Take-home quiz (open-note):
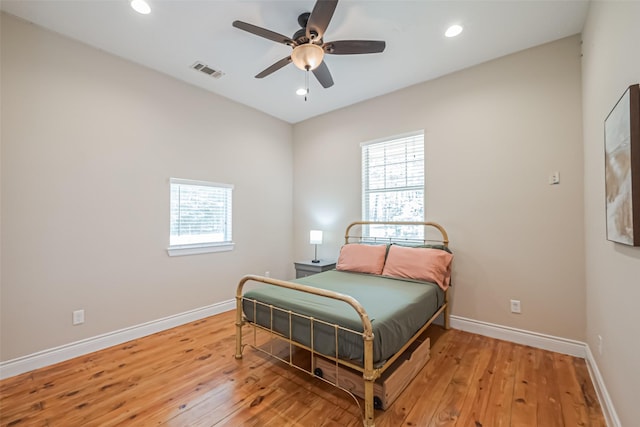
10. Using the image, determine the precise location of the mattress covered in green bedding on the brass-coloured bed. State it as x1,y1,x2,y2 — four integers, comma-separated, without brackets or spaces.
243,270,444,365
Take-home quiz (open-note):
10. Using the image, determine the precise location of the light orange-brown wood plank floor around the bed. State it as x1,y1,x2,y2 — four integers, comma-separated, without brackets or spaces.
0,313,606,427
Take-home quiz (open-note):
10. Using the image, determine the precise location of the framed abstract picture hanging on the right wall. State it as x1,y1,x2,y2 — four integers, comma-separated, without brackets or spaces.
604,84,640,246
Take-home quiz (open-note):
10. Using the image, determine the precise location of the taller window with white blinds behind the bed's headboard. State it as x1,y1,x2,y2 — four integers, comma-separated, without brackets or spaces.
362,131,424,238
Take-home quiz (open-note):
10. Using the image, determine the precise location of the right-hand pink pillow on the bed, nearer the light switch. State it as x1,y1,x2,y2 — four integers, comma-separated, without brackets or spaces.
382,245,453,290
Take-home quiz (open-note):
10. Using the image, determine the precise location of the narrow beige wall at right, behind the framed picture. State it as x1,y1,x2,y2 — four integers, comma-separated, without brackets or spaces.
582,1,640,426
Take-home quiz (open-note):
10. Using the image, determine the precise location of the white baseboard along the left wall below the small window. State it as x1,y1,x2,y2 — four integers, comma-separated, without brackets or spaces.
0,300,235,379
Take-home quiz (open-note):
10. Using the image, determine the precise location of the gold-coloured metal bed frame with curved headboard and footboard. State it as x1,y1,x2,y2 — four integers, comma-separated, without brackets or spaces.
235,221,450,427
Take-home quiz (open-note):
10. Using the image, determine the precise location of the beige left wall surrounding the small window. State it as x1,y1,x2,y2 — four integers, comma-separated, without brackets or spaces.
0,14,292,360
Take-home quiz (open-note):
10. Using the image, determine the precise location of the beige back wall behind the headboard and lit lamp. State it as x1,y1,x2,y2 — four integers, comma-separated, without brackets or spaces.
293,36,585,340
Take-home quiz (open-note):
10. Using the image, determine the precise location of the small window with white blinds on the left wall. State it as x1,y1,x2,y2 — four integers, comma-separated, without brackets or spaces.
168,178,234,256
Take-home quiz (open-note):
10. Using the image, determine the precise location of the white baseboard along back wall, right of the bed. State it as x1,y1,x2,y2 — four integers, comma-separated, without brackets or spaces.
451,316,587,359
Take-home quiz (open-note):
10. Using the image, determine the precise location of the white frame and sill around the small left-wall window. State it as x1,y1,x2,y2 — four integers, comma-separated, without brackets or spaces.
167,178,235,256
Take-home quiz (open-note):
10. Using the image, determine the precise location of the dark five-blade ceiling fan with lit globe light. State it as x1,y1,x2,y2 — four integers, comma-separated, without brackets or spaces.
233,0,385,88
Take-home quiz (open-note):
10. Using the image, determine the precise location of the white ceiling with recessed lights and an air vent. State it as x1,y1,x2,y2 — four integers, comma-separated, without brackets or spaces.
1,0,589,123
